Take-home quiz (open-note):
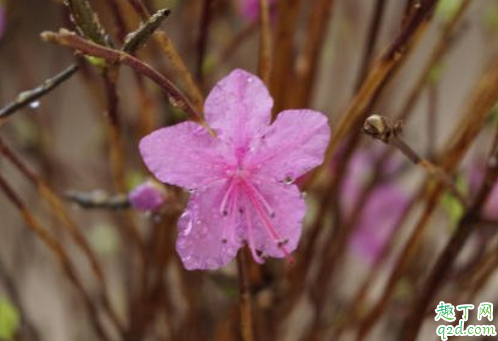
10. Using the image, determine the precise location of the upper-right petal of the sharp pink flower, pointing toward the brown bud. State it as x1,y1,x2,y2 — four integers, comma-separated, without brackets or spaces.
249,109,330,180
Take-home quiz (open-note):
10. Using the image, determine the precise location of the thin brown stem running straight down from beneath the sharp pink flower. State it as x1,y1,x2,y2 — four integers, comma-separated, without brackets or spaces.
237,250,255,341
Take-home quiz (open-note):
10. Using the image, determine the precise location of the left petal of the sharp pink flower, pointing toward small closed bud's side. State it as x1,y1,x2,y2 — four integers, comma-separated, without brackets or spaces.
140,122,225,189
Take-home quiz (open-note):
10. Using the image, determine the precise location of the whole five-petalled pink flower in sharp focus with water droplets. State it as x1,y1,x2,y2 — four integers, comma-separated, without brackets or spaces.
140,70,330,270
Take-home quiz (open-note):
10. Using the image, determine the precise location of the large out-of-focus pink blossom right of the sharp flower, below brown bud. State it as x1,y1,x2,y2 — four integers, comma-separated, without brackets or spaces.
341,151,409,264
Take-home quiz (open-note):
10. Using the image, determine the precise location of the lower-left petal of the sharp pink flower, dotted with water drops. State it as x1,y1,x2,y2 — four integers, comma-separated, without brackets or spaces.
176,183,241,270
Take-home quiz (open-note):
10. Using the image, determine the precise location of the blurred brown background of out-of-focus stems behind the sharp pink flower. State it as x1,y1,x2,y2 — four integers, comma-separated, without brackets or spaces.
0,0,498,341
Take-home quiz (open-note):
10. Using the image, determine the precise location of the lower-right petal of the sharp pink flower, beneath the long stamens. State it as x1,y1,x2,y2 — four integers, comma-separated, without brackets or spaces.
241,181,306,258
